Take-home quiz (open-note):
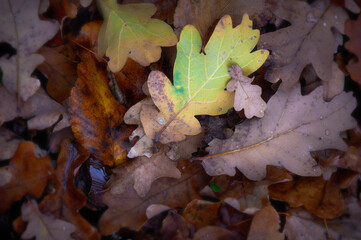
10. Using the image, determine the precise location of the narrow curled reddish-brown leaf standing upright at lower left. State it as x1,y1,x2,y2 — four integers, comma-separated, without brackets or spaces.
39,140,99,239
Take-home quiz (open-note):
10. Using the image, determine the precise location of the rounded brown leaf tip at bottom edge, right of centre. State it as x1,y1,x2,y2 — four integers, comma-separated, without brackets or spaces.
247,206,285,240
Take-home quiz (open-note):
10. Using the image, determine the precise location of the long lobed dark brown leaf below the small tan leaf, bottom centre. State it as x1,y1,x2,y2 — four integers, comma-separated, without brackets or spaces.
98,161,209,235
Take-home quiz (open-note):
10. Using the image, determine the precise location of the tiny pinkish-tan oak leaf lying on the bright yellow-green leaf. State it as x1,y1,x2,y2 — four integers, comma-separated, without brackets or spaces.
227,65,267,118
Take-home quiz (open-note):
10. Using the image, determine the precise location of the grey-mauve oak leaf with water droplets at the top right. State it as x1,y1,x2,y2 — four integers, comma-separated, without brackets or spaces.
259,0,348,95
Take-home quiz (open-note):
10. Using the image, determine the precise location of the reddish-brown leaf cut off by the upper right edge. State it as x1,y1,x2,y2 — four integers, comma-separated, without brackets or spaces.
345,13,361,85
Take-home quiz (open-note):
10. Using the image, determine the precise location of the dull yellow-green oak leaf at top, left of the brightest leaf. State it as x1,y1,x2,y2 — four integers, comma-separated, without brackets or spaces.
97,0,177,72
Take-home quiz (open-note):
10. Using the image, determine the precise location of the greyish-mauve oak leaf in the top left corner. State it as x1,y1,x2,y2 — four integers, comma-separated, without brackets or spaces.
0,0,59,101
